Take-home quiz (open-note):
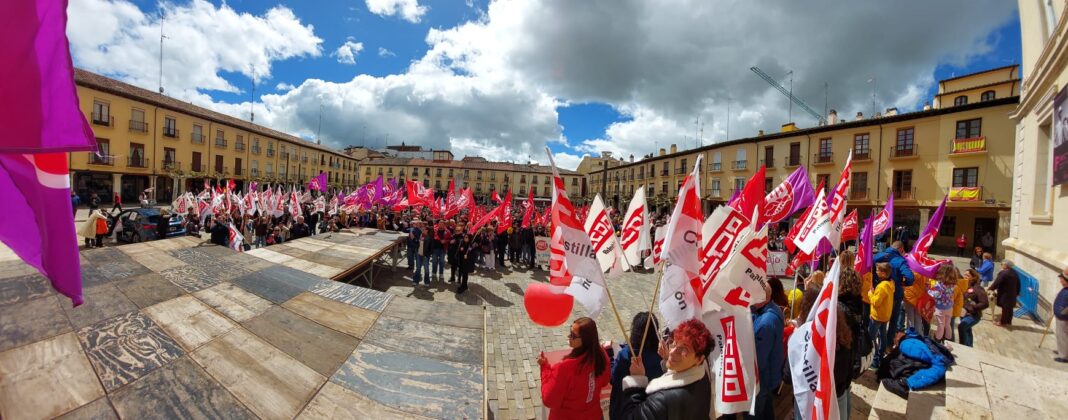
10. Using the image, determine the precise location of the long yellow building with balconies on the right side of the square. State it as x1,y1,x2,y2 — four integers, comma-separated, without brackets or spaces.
587,66,1020,254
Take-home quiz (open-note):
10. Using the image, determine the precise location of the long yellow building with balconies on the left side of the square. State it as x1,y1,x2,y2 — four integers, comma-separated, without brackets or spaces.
69,69,357,202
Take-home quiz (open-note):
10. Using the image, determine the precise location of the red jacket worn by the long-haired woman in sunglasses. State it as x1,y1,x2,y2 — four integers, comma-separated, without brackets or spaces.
541,349,612,420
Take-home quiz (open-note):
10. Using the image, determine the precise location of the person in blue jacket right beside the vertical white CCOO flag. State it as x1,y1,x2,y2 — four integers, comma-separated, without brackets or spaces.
745,283,786,419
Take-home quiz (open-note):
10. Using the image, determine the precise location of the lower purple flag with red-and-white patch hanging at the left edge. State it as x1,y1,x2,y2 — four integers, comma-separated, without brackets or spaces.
0,153,82,307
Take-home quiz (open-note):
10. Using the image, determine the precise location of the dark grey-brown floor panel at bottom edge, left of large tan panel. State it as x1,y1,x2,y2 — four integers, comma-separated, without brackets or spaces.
111,357,256,419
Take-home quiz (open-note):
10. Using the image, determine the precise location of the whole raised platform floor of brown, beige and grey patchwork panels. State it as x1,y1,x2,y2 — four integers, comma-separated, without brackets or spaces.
0,230,485,419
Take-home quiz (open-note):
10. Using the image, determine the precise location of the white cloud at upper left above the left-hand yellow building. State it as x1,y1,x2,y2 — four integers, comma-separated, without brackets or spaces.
67,0,323,98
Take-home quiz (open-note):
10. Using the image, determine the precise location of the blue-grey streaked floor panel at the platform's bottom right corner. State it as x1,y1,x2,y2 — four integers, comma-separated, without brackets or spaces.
330,342,483,419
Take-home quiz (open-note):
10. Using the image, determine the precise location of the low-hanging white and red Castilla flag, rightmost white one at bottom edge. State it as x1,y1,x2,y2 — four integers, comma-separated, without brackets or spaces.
786,260,842,420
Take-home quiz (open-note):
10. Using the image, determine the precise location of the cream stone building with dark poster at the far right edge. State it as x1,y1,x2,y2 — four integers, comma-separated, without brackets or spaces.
1003,1,1068,314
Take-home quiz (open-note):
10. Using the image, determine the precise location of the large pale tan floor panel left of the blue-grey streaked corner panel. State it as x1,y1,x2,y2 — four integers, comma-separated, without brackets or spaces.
192,328,326,419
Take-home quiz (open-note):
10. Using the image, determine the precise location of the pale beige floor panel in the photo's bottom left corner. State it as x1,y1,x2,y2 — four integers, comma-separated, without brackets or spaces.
0,331,104,419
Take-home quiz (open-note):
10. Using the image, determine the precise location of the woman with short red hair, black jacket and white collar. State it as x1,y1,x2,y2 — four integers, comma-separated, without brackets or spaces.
619,320,713,419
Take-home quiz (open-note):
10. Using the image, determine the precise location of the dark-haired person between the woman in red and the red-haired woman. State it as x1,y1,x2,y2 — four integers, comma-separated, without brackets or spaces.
608,312,664,420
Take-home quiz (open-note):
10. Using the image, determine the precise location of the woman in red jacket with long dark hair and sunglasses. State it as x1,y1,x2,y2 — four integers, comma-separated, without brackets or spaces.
537,317,609,420
